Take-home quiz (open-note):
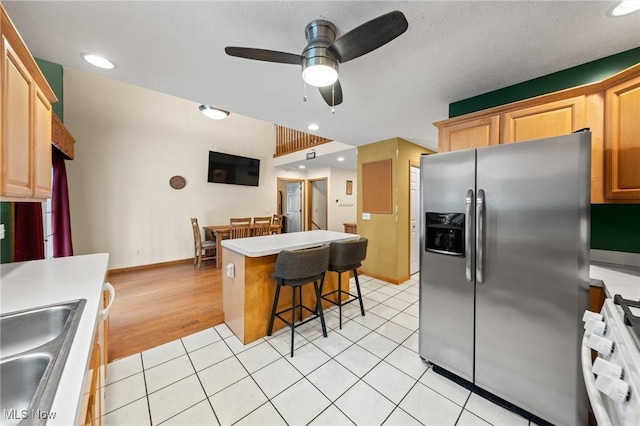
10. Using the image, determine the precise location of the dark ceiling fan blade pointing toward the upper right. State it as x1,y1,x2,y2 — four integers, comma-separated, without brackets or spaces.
328,10,409,62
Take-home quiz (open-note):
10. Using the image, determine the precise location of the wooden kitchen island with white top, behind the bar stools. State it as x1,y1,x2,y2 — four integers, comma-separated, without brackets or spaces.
222,230,359,345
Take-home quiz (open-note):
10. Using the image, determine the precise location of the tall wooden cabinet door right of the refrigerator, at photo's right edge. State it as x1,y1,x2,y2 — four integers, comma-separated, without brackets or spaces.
605,76,640,202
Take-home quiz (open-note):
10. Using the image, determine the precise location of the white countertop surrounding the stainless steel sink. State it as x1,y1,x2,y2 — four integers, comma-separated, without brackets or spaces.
0,253,109,425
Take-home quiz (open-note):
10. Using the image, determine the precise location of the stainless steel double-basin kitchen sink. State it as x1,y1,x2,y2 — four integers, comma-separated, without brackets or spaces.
0,299,86,426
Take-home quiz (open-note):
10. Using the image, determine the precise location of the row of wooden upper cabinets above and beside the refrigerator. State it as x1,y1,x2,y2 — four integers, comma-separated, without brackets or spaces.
434,64,640,203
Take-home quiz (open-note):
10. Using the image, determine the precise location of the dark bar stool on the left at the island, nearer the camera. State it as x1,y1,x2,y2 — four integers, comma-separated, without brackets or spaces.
267,245,330,357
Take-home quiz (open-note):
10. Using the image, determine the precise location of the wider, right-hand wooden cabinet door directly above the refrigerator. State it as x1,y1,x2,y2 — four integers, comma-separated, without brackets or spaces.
501,96,586,143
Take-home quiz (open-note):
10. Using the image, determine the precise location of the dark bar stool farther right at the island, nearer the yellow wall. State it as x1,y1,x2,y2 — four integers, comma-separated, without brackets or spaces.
321,238,369,329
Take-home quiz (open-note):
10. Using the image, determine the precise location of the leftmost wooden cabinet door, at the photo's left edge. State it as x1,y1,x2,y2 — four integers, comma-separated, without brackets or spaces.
0,39,33,197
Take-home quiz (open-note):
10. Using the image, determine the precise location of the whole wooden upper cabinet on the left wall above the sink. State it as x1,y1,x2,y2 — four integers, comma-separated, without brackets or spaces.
0,4,57,200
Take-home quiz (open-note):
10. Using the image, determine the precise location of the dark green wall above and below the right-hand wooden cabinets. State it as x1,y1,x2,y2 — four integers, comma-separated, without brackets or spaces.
449,47,640,253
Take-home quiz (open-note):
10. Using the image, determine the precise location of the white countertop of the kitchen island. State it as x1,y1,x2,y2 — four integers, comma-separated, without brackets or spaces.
222,230,360,257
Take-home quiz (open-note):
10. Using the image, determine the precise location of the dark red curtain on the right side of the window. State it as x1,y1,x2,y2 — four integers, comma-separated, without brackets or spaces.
51,146,73,257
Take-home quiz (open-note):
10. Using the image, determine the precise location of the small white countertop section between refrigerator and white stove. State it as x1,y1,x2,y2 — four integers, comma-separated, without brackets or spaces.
589,262,640,300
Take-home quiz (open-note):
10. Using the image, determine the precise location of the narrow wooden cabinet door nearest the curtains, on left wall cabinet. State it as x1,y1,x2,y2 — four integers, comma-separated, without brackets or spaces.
33,87,51,198
